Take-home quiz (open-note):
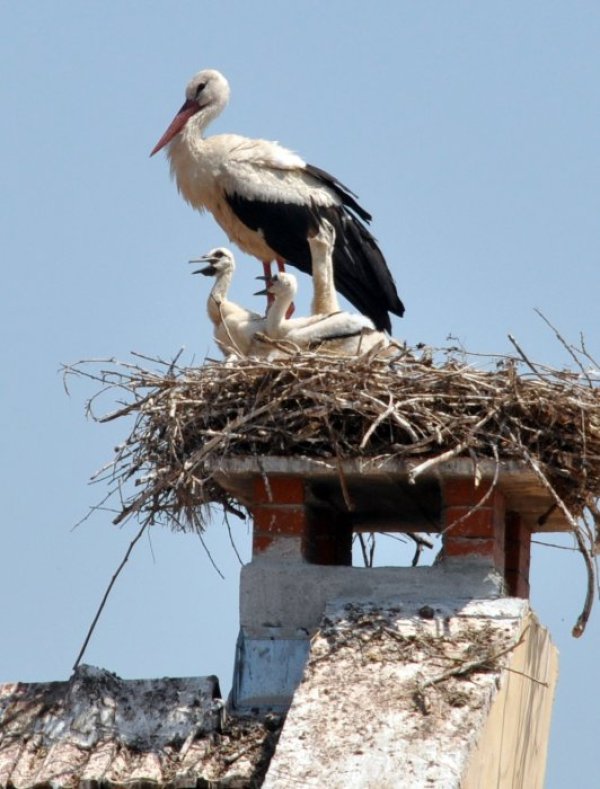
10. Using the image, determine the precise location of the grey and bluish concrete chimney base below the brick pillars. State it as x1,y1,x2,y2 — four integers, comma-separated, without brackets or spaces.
232,558,508,711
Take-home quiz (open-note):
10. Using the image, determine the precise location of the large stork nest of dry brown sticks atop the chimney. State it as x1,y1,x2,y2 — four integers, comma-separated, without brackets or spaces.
65,343,600,636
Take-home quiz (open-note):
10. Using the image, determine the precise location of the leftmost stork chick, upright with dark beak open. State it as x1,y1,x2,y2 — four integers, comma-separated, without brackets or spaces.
190,247,265,359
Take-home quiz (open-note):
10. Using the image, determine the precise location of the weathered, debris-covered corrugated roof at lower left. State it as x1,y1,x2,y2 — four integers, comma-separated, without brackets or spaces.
0,666,281,789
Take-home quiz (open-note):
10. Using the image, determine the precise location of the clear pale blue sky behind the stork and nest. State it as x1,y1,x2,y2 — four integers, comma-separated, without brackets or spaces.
0,0,600,789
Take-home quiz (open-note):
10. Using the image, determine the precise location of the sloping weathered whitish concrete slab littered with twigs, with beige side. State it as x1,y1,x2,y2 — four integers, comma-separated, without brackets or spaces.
264,600,556,789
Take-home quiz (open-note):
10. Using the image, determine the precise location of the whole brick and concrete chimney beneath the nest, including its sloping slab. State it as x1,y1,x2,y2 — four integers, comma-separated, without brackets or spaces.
219,457,569,787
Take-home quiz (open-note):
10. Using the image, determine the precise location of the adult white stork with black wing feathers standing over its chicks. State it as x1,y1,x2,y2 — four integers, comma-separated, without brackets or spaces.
150,63,404,331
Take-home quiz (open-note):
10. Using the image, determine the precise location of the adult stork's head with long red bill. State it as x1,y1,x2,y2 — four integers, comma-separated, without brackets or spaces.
150,69,229,156
